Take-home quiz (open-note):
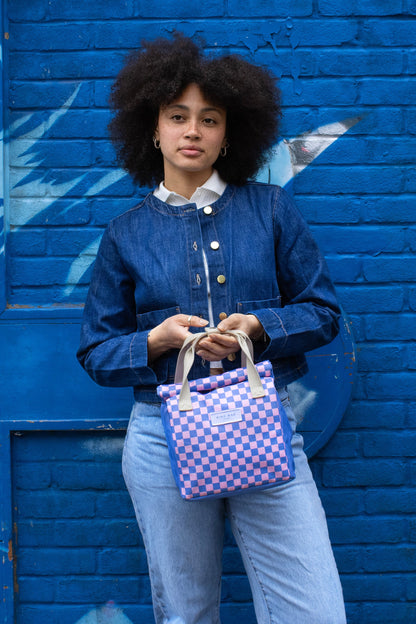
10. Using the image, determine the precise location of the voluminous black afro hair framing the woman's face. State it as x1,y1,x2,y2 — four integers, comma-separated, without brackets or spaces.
109,33,281,187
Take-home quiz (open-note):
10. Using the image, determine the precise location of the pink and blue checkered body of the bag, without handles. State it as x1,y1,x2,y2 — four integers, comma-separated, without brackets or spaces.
158,361,295,499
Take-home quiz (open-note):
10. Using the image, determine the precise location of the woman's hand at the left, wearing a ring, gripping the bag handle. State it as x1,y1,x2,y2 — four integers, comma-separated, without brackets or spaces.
147,314,208,364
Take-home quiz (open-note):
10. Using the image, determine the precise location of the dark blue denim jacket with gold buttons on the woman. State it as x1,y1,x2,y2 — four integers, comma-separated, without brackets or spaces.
77,183,340,401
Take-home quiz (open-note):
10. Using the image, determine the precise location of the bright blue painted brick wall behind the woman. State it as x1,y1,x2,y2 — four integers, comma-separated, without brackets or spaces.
0,0,416,624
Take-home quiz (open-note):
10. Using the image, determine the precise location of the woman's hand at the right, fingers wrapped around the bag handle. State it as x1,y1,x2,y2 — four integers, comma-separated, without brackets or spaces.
196,313,264,362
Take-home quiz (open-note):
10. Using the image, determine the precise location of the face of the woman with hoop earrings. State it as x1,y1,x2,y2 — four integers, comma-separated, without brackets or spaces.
155,84,227,190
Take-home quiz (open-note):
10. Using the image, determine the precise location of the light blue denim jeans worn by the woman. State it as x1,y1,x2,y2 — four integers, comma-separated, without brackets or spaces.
123,391,346,624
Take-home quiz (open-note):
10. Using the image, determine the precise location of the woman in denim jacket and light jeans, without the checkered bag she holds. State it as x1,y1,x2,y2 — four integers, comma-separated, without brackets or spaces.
78,35,345,624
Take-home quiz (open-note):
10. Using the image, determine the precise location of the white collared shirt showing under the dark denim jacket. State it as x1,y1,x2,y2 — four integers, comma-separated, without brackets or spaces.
153,169,227,368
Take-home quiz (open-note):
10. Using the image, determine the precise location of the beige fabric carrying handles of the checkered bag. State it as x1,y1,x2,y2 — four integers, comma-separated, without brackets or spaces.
175,327,266,412
